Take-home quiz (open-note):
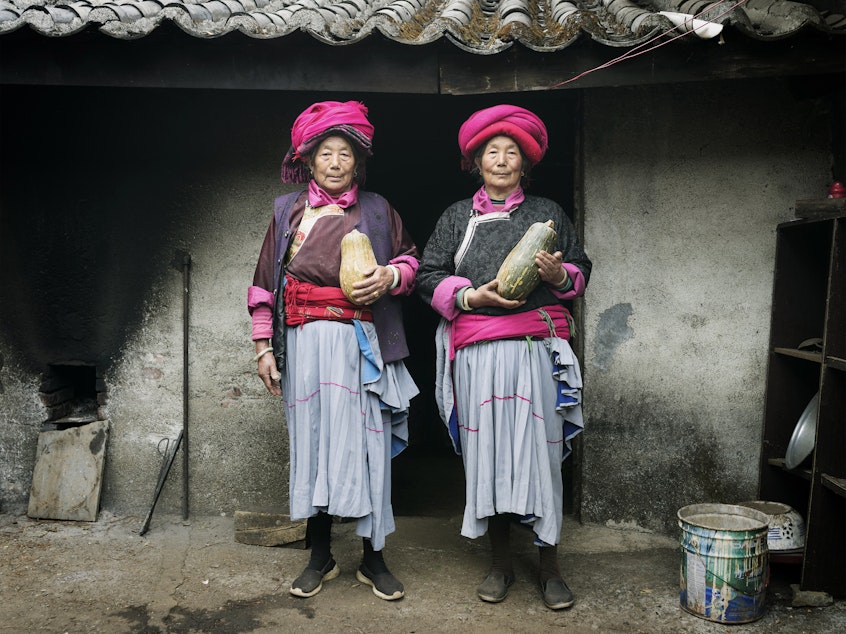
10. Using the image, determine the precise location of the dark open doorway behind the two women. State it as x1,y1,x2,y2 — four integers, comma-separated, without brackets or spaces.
362,92,576,516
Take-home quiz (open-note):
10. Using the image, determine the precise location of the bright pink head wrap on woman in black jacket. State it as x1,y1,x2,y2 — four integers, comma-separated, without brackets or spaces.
458,104,549,170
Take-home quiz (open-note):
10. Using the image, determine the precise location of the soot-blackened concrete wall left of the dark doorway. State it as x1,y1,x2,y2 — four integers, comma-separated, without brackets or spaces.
0,88,307,515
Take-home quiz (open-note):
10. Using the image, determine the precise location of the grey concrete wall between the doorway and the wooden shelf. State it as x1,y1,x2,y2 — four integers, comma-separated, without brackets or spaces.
582,82,831,531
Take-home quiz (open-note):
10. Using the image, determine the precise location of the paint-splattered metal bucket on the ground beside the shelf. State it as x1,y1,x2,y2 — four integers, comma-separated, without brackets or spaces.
678,504,770,623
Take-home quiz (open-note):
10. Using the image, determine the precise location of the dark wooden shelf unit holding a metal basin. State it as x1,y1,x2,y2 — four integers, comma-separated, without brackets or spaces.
759,215,846,598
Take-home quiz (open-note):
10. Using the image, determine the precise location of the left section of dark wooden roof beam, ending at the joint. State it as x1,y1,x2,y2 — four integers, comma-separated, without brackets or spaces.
0,23,438,94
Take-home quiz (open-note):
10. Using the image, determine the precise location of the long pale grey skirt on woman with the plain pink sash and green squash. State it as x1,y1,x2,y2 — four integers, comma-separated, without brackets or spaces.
452,337,584,545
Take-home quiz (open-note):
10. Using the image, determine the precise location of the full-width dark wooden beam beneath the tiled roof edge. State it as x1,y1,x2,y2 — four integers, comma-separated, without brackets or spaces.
0,23,846,95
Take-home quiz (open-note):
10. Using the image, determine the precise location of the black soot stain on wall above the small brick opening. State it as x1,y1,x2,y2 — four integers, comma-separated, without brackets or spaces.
0,87,260,370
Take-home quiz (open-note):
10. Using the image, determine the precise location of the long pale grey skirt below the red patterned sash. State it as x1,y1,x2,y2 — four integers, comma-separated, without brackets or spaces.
282,320,418,550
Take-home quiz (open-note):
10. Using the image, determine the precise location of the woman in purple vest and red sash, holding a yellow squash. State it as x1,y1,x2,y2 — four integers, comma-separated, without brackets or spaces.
248,101,419,600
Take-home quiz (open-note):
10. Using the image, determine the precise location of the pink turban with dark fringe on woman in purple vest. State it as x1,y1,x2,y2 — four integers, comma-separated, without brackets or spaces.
282,101,373,183
